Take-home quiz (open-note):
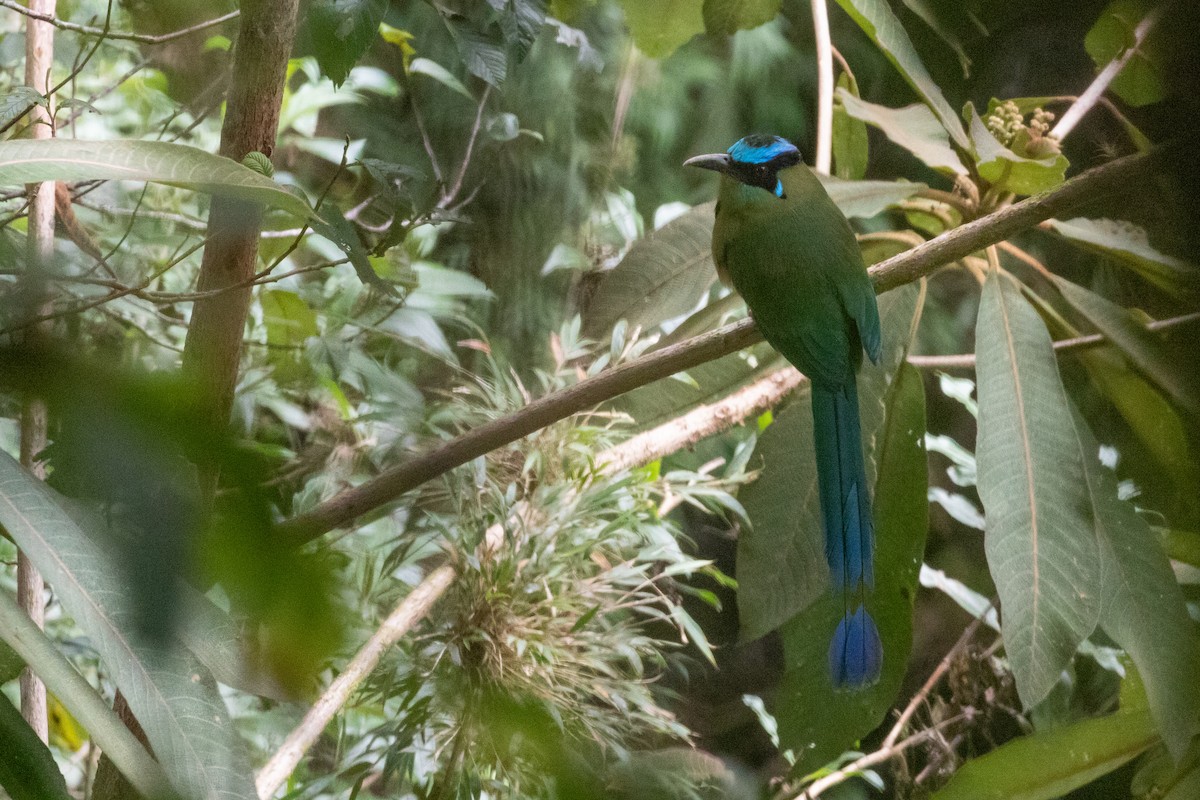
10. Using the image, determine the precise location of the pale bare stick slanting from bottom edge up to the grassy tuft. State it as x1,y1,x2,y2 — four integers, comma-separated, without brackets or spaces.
254,565,455,800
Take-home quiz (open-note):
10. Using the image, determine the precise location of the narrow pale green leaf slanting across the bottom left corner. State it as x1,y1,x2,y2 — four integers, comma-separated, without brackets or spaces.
0,591,167,798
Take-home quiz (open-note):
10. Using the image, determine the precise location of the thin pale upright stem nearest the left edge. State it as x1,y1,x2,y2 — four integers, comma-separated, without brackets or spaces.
17,0,58,741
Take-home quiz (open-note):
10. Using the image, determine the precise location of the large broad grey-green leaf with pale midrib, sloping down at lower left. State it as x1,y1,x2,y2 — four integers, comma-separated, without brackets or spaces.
0,453,256,800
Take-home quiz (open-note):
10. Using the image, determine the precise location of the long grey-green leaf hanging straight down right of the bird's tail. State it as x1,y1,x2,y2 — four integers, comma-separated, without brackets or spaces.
976,271,1100,708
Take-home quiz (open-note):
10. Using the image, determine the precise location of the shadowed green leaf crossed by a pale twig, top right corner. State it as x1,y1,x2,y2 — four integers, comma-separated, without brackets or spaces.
1084,0,1166,107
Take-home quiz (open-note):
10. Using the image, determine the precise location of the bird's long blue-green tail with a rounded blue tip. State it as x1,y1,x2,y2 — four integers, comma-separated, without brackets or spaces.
812,380,883,688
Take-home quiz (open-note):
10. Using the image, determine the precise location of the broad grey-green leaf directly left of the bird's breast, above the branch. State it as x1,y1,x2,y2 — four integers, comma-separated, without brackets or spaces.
583,203,716,339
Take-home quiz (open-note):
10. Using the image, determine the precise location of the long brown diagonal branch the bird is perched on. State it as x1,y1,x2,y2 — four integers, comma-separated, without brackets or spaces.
277,143,1183,545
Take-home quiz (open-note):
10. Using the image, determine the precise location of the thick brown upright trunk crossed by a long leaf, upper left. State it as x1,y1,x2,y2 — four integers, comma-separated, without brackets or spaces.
184,0,299,450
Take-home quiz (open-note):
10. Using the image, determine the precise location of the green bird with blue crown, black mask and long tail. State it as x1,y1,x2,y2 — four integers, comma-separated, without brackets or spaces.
684,134,883,688
